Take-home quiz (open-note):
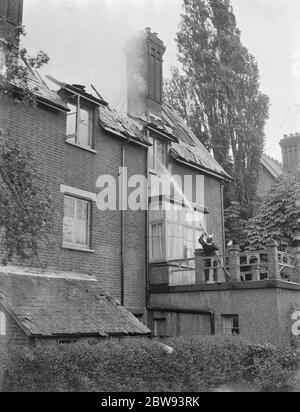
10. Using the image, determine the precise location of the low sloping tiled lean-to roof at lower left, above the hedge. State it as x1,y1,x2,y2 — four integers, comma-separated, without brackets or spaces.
0,272,150,337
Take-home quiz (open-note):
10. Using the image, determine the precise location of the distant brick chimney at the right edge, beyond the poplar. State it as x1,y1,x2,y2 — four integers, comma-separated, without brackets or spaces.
280,133,300,172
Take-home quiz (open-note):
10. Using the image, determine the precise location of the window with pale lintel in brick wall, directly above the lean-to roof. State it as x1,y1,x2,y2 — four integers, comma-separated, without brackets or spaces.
63,196,91,249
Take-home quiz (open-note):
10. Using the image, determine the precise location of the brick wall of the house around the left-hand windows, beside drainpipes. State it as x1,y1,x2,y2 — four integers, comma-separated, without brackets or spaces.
0,97,146,312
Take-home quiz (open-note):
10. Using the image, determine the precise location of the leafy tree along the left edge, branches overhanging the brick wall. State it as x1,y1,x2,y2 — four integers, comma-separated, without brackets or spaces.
0,28,52,264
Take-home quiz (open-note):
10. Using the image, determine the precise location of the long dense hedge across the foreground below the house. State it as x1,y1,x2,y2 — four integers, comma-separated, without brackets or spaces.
0,336,300,392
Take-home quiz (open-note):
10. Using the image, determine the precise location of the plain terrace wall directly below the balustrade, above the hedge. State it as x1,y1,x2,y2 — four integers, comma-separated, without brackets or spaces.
151,283,299,346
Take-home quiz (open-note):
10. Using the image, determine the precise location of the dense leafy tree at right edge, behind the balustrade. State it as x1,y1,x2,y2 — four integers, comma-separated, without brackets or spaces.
246,169,300,249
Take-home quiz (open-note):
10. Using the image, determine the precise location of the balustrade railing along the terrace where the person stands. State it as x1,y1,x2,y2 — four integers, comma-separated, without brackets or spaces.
168,242,300,286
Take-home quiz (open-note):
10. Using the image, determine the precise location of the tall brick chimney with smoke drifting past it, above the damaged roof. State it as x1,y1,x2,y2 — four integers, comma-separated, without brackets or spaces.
125,27,166,118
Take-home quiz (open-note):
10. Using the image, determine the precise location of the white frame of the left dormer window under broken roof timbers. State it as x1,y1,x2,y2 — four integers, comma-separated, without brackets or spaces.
66,95,94,151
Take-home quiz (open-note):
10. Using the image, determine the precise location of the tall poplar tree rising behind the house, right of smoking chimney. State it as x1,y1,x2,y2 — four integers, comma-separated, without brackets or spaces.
165,0,269,219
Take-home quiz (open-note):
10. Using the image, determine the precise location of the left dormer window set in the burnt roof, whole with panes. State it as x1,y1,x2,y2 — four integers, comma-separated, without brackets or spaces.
67,96,94,149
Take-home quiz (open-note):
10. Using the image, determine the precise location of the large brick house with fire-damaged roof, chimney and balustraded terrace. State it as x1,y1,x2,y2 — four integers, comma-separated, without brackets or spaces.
0,0,300,344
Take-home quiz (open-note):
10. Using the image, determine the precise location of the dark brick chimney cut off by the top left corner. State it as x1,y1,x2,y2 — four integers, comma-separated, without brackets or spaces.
0,0,23,43
